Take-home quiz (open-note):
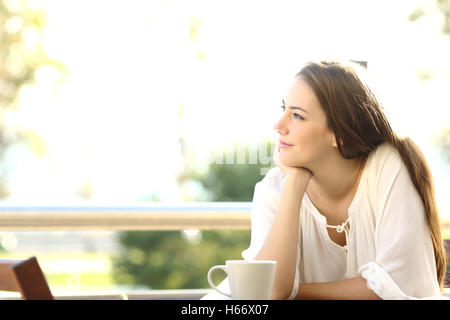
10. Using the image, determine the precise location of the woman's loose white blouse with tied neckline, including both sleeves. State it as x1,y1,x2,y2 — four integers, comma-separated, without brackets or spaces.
204,142,443,299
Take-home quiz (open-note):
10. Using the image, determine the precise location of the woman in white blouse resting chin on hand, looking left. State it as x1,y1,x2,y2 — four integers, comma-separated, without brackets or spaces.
204,62,446,299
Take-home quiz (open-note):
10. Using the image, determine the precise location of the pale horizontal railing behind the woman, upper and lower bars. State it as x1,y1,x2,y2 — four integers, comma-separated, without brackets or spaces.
0,202,450,299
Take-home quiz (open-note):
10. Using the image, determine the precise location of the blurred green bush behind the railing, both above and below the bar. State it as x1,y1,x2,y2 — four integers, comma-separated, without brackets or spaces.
113,142,272,289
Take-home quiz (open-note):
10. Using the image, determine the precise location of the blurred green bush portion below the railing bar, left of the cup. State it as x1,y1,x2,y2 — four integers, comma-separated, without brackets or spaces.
113,230,250,289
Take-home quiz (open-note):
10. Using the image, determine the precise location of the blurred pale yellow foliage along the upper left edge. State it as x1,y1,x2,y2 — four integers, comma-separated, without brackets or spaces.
0,0,68,198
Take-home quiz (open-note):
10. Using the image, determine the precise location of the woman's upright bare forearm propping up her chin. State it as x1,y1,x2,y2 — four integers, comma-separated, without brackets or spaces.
255,172,310,299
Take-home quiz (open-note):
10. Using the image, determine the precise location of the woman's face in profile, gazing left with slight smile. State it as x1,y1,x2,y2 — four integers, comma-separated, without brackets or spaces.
274,78,335,169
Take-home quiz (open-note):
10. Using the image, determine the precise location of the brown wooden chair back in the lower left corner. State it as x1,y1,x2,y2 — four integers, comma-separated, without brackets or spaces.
0,257,54,300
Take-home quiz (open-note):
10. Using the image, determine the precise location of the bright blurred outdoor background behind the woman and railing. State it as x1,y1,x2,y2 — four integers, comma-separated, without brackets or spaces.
0,0,450,291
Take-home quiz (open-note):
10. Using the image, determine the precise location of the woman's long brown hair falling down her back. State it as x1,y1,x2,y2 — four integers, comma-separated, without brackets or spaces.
296,61,447,289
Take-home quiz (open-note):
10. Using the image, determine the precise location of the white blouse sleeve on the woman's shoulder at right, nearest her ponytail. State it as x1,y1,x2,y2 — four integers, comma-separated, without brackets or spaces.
358,151,441,299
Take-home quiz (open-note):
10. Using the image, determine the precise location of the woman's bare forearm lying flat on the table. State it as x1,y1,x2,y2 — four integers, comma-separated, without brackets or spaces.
295,277,380,300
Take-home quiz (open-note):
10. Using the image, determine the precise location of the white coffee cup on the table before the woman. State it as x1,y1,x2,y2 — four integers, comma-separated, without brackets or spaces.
208,260,277,300
